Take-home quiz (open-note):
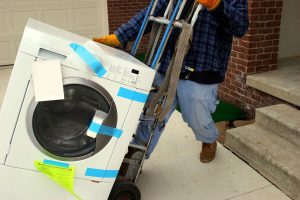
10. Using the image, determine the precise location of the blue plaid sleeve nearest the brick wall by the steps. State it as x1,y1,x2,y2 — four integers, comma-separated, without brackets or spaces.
211,0,249,37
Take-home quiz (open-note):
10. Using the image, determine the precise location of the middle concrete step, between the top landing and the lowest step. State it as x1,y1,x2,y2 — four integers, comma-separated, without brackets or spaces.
255,104,300,146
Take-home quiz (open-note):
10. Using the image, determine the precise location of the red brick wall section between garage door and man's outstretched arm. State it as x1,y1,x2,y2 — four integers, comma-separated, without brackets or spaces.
107,0,150,52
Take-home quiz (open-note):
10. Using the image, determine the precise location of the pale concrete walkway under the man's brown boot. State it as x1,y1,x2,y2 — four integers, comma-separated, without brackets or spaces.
0,68,289,200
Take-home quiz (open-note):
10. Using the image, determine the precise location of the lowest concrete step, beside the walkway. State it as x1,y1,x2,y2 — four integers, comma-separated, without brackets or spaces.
225,124,300,200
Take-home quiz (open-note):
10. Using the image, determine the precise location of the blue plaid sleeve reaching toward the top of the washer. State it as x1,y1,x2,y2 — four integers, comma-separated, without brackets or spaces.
114,0,168,47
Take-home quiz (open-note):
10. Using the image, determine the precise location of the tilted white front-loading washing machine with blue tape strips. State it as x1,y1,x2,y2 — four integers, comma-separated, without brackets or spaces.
0,19,155,200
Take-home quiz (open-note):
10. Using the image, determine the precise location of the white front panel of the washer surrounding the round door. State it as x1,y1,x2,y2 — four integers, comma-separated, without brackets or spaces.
5,67,134,181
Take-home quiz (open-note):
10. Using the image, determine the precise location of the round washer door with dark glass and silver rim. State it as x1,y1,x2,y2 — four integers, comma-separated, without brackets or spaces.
29,78,117,160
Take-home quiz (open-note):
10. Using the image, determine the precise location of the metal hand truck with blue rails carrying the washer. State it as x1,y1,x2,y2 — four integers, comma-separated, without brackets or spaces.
109,0,202,200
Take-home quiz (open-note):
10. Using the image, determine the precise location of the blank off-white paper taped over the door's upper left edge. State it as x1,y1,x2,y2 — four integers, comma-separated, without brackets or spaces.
32,60,64,102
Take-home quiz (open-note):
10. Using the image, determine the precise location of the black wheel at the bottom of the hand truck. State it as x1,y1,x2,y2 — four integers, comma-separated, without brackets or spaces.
108,182,141,200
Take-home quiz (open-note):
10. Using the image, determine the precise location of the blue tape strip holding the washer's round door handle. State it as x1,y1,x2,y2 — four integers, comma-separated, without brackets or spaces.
89,122,123,138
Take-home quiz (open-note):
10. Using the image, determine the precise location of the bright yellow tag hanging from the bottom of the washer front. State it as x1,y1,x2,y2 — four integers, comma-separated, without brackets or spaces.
34,161,81,199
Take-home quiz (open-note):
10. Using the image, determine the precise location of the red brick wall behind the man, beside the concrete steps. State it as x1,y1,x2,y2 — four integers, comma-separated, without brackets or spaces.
219,0,283,115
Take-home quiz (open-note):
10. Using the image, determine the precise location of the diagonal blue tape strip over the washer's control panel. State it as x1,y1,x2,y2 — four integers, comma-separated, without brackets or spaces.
70,43,107,77
